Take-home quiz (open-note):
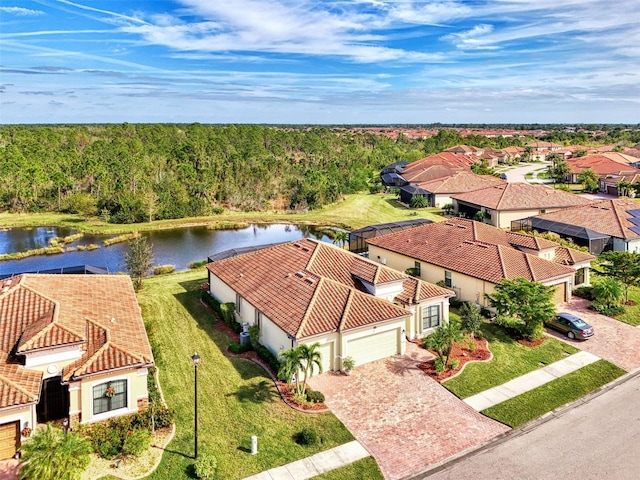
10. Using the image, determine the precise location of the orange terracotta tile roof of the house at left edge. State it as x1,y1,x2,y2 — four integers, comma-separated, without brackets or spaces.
0,274,153,406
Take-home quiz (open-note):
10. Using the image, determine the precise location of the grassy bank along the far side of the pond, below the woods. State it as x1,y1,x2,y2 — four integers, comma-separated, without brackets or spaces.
0,193,442,235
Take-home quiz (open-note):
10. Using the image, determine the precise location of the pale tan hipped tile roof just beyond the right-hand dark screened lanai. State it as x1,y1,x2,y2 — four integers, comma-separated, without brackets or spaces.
451,183,591,211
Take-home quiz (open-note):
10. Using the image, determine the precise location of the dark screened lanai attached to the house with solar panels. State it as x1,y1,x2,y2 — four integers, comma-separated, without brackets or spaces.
511,217,612,255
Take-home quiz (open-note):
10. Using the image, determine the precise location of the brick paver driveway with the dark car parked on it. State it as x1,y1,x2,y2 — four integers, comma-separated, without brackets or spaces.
547,298,640,372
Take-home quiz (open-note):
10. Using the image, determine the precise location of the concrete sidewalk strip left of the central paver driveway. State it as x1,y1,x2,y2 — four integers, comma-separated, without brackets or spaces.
245,440,370,480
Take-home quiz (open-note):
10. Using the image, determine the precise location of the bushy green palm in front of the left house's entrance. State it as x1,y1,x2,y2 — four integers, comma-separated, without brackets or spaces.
19,424,92,480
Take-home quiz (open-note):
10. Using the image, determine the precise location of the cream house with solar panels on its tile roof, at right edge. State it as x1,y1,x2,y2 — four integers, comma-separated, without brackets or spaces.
511,198,640,255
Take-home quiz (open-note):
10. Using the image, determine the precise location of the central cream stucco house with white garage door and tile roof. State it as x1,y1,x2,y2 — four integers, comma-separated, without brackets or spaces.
207,239,453,371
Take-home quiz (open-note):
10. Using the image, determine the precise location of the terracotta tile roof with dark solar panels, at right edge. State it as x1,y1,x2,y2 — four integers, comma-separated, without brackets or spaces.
537,198,640,240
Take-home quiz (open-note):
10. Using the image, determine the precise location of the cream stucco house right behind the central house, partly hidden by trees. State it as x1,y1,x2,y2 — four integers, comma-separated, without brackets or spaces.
368,218,595,306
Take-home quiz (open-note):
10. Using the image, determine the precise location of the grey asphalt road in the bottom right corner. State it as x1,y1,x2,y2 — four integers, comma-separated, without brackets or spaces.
414,375,640,480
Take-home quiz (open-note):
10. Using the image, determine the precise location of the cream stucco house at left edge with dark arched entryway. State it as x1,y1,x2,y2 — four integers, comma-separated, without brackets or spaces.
0,274,153,459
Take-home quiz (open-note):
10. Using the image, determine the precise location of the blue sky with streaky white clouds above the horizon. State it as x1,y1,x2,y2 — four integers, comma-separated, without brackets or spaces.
0,0,640,124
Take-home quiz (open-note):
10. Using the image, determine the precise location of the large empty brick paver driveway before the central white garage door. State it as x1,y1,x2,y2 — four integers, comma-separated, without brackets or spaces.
310,343,509,480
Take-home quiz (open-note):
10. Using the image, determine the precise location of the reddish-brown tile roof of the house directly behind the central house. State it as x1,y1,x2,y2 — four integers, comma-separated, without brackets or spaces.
368,218,584,283
